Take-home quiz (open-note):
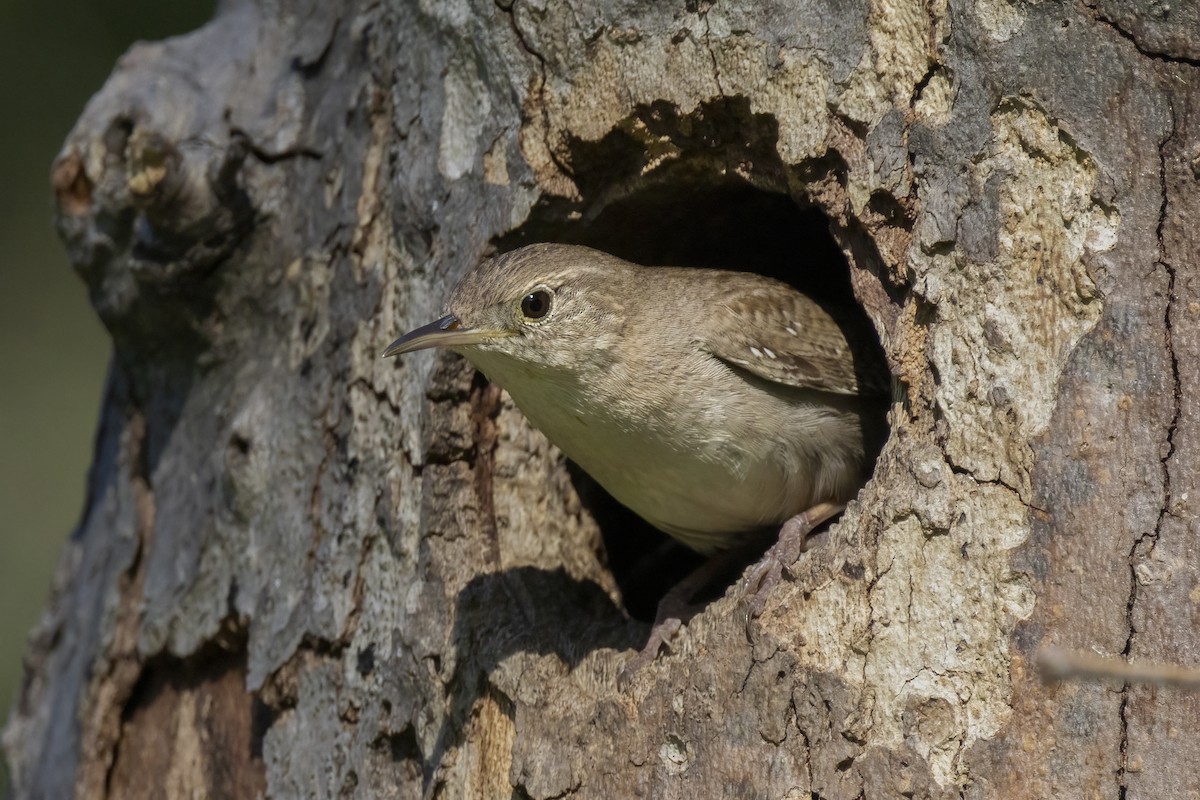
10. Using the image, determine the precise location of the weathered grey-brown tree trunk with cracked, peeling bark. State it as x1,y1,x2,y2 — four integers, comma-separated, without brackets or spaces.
4,0,1200,799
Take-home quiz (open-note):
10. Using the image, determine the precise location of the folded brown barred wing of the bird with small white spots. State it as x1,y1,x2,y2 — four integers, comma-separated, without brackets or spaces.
703,283,889,395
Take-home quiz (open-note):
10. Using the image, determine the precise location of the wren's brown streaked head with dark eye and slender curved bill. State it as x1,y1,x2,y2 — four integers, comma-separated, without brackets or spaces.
384,243,637,383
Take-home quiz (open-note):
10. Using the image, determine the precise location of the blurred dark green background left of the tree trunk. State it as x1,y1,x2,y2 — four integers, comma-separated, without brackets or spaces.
0,0,214,795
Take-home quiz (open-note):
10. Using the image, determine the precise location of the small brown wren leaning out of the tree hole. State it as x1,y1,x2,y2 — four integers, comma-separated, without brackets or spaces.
384,243,890,669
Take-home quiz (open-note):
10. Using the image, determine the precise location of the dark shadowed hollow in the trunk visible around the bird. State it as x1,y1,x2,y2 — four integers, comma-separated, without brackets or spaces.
496,167,886,620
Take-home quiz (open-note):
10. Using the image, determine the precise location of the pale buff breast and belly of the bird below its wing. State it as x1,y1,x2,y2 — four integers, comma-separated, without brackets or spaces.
494,362,860,553
